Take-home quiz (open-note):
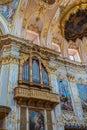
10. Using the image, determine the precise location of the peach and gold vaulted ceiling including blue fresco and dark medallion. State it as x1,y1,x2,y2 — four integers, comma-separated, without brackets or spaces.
0,0,87,46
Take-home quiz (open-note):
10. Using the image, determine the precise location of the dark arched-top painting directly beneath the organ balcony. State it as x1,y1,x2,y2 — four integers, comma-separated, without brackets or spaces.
29,111,45,130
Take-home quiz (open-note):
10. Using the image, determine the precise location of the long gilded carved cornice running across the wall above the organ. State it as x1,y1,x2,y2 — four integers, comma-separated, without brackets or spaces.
0,35,87,70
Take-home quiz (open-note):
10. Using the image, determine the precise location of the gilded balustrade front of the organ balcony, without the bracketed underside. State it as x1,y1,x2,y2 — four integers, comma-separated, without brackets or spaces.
14,87,59,106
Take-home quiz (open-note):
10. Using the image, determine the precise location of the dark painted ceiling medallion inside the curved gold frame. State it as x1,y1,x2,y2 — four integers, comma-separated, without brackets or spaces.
64,9,87,42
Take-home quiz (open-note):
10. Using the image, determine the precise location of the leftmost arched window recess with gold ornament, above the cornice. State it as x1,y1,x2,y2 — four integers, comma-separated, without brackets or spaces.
26,12,44,45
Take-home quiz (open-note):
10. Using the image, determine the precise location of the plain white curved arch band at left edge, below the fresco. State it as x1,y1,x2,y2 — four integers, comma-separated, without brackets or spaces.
0,14,10,34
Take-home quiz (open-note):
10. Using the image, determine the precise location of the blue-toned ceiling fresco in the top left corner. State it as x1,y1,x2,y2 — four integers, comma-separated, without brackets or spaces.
0,0,18,22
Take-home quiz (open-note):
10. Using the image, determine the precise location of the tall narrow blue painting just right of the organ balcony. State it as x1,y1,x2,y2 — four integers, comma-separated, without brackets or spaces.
58,80,73,111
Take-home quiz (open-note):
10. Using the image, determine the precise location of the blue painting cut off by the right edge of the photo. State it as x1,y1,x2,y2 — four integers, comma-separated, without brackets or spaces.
77,84,87,110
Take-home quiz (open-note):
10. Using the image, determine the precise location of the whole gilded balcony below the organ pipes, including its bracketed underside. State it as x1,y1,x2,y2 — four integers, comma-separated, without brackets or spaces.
14,87,59,108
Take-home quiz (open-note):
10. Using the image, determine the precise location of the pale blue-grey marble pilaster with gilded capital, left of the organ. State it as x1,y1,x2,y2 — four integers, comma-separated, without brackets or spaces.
0,43,19,130
